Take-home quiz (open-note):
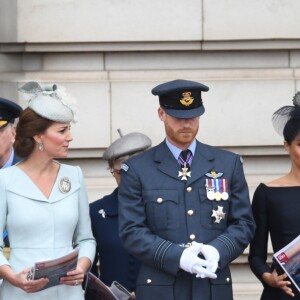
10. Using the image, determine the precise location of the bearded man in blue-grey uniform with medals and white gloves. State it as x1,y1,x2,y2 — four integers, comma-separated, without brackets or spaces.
118,80,255,300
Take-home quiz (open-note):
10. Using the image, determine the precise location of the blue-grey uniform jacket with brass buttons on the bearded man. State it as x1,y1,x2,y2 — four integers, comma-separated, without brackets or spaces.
119,141,255,300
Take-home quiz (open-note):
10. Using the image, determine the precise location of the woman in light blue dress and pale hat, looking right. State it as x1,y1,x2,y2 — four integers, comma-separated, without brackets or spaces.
0,82,95,300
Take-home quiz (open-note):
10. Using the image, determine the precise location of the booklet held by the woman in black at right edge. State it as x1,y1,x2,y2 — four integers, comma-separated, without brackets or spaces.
273,235,300,292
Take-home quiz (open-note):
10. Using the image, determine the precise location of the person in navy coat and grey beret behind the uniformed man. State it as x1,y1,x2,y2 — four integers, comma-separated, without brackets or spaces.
86,130,152,300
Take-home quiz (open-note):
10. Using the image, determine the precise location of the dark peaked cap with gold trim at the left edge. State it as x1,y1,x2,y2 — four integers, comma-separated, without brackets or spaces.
0,98,23,128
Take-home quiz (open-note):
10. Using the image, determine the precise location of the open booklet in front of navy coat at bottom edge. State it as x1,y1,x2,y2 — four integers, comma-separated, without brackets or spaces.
85,272,134,300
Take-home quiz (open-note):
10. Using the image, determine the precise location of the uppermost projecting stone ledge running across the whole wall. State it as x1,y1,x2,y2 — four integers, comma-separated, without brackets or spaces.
0,39,300,53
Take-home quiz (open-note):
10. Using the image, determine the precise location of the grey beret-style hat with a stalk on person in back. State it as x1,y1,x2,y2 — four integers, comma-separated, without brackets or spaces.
103,129,152,160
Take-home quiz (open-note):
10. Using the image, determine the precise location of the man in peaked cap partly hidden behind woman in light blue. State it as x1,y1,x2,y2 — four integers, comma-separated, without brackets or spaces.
0,98,23,262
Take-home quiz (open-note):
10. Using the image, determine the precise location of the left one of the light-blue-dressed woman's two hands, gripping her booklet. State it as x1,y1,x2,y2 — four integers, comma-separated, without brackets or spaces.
13,268,49,293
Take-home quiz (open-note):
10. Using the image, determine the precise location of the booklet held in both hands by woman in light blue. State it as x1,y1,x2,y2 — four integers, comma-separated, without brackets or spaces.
27,247,79,290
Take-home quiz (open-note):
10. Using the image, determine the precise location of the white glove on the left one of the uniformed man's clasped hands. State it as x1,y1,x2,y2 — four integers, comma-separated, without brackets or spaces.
179,242,217,279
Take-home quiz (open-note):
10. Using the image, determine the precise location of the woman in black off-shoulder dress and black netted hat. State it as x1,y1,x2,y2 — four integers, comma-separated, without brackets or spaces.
249,92,300,300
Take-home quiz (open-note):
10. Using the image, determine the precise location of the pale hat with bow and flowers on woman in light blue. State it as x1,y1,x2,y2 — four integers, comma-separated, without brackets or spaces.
18,81,77,123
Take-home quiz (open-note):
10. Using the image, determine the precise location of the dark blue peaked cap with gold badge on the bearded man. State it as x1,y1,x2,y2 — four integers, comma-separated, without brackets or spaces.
151,79,209,119
